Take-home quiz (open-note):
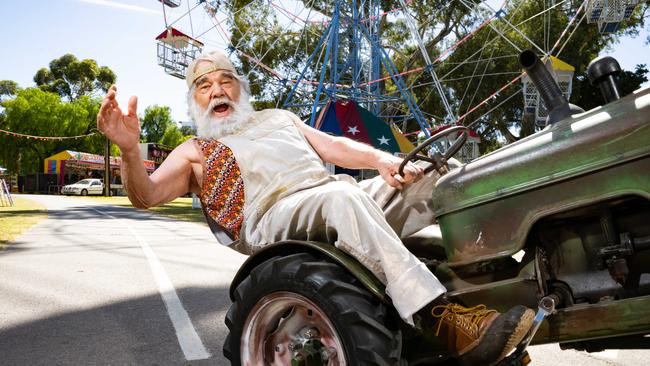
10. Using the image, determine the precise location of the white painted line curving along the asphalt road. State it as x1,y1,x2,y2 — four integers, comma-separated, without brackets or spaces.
92,208,210,361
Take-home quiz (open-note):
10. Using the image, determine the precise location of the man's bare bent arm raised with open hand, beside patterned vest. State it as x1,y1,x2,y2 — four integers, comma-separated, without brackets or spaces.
97,85,196,208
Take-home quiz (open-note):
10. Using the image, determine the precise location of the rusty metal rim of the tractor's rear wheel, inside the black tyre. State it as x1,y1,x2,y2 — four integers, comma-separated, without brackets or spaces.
240,292,346,365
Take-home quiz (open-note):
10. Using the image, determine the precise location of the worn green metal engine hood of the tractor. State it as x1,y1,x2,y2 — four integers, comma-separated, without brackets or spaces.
433,88,650,265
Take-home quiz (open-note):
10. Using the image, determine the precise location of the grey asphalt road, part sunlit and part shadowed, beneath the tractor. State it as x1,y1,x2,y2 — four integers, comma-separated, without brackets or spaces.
0,196,650,366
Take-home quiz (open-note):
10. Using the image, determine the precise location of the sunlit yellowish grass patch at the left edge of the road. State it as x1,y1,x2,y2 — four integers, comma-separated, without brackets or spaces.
0,196,47,246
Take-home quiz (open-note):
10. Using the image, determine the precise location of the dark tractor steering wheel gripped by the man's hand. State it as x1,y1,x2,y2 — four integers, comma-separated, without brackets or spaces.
399,126,469,176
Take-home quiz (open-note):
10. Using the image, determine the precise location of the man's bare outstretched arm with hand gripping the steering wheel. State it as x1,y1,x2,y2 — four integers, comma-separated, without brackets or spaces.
295,121,423,188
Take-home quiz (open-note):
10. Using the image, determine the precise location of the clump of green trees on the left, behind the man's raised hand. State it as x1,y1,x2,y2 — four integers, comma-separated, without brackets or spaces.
0,54,182,174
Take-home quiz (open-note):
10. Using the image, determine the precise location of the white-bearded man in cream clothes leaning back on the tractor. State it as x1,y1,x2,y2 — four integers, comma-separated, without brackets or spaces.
97,52,534,365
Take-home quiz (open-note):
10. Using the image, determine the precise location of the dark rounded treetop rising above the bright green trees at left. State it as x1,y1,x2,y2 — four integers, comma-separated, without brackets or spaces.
34,53,116,101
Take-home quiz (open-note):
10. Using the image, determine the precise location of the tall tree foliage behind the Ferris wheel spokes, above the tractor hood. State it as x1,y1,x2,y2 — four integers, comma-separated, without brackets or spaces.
221,0,650,152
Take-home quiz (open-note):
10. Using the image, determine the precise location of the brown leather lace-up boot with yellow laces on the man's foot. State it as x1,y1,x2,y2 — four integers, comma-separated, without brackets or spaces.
431,304,535,365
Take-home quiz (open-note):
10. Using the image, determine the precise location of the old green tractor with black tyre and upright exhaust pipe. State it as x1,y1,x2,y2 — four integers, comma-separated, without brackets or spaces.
213,51,650,365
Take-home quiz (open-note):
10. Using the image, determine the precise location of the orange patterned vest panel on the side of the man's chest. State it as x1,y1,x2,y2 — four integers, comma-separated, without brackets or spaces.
197,139,244,240
